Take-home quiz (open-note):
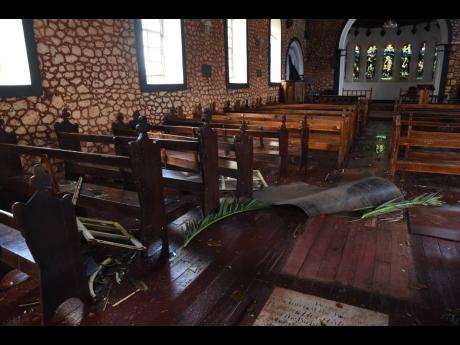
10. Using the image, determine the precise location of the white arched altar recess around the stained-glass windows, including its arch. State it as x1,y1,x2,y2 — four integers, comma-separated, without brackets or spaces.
336,19,451,100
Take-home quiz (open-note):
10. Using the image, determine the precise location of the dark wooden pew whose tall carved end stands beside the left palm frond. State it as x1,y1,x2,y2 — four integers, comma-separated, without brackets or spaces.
0,127,169,252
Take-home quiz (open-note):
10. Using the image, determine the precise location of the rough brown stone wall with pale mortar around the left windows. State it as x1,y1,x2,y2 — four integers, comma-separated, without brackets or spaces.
0,19,304,149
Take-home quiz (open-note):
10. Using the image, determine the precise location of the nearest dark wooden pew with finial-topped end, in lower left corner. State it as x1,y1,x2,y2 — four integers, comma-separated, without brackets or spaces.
0,165,89,325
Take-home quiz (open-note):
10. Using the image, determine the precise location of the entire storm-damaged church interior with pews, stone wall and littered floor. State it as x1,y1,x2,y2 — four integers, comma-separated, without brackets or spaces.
0,18,460,326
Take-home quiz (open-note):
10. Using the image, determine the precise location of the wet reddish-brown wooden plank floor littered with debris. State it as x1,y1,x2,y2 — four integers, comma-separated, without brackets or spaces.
0,114,460,325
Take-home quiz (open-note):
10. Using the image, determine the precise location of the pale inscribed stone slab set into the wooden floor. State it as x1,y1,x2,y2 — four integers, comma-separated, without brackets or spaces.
254,288,389,326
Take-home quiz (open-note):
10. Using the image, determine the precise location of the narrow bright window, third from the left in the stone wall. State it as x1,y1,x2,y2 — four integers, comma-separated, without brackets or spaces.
226,19,248,86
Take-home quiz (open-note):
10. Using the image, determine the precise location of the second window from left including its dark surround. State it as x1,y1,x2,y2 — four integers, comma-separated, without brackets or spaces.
136,19,186,91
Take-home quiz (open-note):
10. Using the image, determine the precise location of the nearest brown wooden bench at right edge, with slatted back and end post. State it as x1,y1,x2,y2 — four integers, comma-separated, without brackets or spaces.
389,115,460,178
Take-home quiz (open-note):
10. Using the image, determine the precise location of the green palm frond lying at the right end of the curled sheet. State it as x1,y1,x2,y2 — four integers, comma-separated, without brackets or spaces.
360,193,444,219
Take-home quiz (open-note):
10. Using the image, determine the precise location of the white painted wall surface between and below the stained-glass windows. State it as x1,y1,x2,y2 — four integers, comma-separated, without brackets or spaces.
339,20,447,100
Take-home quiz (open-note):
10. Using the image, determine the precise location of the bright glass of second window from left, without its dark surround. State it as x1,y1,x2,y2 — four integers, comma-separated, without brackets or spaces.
141,19,184,85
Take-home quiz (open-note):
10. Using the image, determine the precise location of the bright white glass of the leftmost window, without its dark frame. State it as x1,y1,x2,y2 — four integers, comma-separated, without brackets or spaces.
0,19,32,86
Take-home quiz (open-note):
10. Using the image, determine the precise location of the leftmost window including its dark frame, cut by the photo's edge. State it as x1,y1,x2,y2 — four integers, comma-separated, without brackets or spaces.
0,19,42,97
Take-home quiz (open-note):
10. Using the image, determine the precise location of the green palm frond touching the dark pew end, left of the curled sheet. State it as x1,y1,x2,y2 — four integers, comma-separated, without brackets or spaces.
184,199,272,247
